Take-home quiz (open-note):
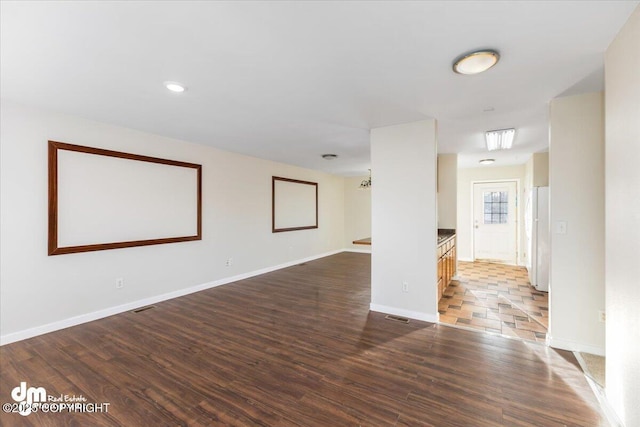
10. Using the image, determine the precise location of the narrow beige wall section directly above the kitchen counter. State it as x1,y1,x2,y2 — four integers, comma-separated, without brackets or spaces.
438,154,458,229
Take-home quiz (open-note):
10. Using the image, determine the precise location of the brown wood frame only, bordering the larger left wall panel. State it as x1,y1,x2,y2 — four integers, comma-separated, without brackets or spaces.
48,141,202,255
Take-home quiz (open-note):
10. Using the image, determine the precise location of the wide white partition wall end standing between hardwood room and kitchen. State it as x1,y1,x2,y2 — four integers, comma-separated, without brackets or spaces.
371,120,437,322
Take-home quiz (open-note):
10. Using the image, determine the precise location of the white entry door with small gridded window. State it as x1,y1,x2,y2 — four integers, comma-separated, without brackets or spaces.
473,181,518,264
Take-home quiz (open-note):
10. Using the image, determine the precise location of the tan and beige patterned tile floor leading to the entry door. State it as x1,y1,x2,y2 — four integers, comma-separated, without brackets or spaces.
438,261,549,342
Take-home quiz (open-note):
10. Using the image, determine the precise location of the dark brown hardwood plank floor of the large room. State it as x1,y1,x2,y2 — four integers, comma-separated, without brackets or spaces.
0,253,606,426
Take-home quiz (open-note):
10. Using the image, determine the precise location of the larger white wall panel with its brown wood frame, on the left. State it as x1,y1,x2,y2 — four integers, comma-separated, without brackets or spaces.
48,141,202,255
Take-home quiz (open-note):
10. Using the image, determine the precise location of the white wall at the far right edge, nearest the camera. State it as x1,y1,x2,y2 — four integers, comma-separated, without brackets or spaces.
605,7,640,427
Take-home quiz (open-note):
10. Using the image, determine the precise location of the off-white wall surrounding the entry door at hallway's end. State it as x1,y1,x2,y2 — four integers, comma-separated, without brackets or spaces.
456,165,526,265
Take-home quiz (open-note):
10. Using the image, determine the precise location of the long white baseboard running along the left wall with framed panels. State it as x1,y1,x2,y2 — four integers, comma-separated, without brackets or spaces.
0,249,343,346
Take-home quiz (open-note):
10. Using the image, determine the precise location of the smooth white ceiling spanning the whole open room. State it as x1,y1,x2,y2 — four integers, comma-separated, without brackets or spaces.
0,1,638,175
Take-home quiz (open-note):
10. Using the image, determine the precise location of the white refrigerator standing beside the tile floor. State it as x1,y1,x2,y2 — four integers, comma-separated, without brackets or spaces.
525,187,550,292
